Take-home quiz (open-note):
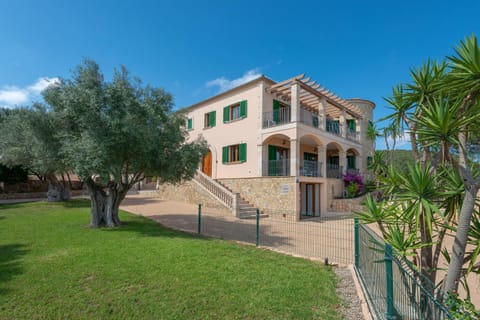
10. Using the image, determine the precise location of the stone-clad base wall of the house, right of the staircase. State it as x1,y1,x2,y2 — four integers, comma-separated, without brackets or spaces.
218,177,297,214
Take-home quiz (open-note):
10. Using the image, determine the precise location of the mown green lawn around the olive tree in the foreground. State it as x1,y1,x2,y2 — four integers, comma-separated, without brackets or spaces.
0,200,341,319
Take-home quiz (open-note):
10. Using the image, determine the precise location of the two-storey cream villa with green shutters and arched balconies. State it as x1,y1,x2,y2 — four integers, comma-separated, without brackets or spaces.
169,74,375,219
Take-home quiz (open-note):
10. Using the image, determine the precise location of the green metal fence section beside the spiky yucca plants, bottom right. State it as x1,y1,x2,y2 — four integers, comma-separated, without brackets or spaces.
354,220,453,320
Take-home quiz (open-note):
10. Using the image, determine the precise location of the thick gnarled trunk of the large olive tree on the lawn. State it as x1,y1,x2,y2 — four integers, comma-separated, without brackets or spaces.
86,179,127,228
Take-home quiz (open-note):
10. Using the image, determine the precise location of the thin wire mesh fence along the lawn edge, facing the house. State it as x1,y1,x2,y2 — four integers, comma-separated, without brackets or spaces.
194,210,354,265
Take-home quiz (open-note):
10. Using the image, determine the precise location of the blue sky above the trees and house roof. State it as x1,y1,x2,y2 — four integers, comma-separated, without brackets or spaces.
0,0,480,148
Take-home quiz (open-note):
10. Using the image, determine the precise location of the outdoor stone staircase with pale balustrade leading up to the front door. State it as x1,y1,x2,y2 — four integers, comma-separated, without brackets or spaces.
193,171,257,219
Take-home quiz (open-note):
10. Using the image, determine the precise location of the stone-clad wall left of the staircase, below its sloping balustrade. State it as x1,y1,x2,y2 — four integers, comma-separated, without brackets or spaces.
157,181,229,210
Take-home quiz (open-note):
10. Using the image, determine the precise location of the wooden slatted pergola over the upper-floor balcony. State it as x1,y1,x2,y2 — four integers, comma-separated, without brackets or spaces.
266,73,362,119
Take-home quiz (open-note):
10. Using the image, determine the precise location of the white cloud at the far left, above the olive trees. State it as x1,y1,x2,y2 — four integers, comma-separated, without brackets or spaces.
0,77,60,108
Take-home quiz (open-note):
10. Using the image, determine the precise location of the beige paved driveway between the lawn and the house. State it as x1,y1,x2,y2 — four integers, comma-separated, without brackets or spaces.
121,195,353,265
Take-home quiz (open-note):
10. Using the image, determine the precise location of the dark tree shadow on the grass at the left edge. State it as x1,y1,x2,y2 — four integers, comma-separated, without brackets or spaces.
0,243,28,295
